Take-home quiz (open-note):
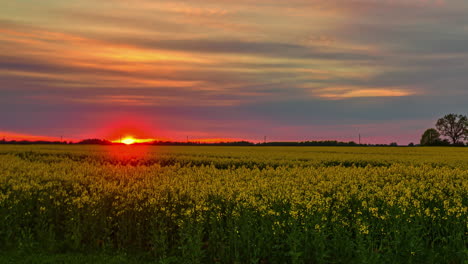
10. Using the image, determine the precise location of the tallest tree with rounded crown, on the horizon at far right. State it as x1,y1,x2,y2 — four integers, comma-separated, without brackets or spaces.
436,114,468,145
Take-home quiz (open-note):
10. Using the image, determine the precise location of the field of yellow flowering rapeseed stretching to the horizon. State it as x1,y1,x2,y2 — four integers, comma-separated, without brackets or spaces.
0,145,468,264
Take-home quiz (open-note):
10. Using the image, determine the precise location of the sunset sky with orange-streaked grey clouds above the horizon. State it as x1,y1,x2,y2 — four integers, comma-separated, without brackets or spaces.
0,0,468,144
